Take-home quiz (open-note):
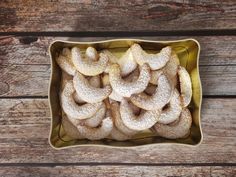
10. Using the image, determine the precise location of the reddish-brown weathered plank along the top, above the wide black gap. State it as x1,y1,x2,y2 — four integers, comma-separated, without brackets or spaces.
0,0,236,32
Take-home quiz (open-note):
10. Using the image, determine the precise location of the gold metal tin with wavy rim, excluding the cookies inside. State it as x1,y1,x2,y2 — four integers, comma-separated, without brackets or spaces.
49,39,202,148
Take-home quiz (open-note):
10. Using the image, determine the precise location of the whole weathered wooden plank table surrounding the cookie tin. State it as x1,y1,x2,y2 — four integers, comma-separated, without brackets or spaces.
0,0,236,176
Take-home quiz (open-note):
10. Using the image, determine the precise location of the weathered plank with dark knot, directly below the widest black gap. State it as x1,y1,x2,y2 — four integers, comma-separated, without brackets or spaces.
0,36,236,65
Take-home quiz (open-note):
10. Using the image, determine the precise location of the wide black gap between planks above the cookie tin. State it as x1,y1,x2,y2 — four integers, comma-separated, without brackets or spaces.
0,29,236,37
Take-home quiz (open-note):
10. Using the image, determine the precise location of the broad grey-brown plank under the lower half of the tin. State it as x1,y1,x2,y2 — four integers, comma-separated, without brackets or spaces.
0,98,236,164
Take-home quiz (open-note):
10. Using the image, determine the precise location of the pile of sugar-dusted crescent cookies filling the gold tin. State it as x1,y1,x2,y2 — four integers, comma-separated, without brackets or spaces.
56,43,192,141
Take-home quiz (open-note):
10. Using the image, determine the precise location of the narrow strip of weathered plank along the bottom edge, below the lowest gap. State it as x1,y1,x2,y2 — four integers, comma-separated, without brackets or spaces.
0,166,236,177
